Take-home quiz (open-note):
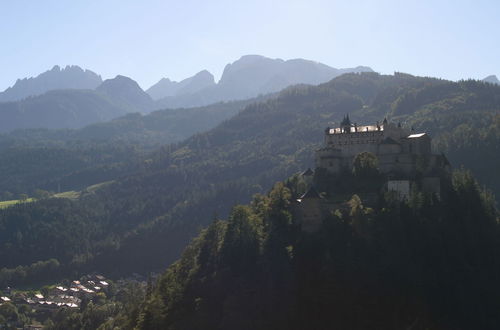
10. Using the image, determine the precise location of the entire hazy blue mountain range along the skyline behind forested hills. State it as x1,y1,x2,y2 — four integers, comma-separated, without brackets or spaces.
0,55,372,132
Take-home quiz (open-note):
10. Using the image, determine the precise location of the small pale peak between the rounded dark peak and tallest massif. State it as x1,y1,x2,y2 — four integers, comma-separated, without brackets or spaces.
146,70,215,100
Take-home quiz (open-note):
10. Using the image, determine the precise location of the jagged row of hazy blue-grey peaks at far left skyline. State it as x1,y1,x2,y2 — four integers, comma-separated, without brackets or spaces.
0,65,102,102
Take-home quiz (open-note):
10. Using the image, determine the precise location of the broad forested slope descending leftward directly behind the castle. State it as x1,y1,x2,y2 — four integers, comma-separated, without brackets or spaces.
0,73,500,288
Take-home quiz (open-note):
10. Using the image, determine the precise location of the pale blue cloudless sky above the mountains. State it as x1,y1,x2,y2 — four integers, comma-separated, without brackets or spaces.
0,0,500,90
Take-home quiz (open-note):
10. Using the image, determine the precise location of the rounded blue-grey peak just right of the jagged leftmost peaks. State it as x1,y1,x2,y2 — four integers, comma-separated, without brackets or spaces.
96,75,155,112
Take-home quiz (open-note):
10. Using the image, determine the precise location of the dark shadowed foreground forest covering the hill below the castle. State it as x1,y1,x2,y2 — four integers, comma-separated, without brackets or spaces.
44,171,500,330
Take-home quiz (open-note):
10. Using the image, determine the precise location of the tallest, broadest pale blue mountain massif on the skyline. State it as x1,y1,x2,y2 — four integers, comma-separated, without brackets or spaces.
158,55,373,108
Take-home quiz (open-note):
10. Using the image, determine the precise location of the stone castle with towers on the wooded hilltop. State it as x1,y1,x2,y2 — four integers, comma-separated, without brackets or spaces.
297,115,450,232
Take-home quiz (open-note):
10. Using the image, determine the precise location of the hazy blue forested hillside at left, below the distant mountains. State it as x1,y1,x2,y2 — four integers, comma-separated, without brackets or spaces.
0,95,272,200
